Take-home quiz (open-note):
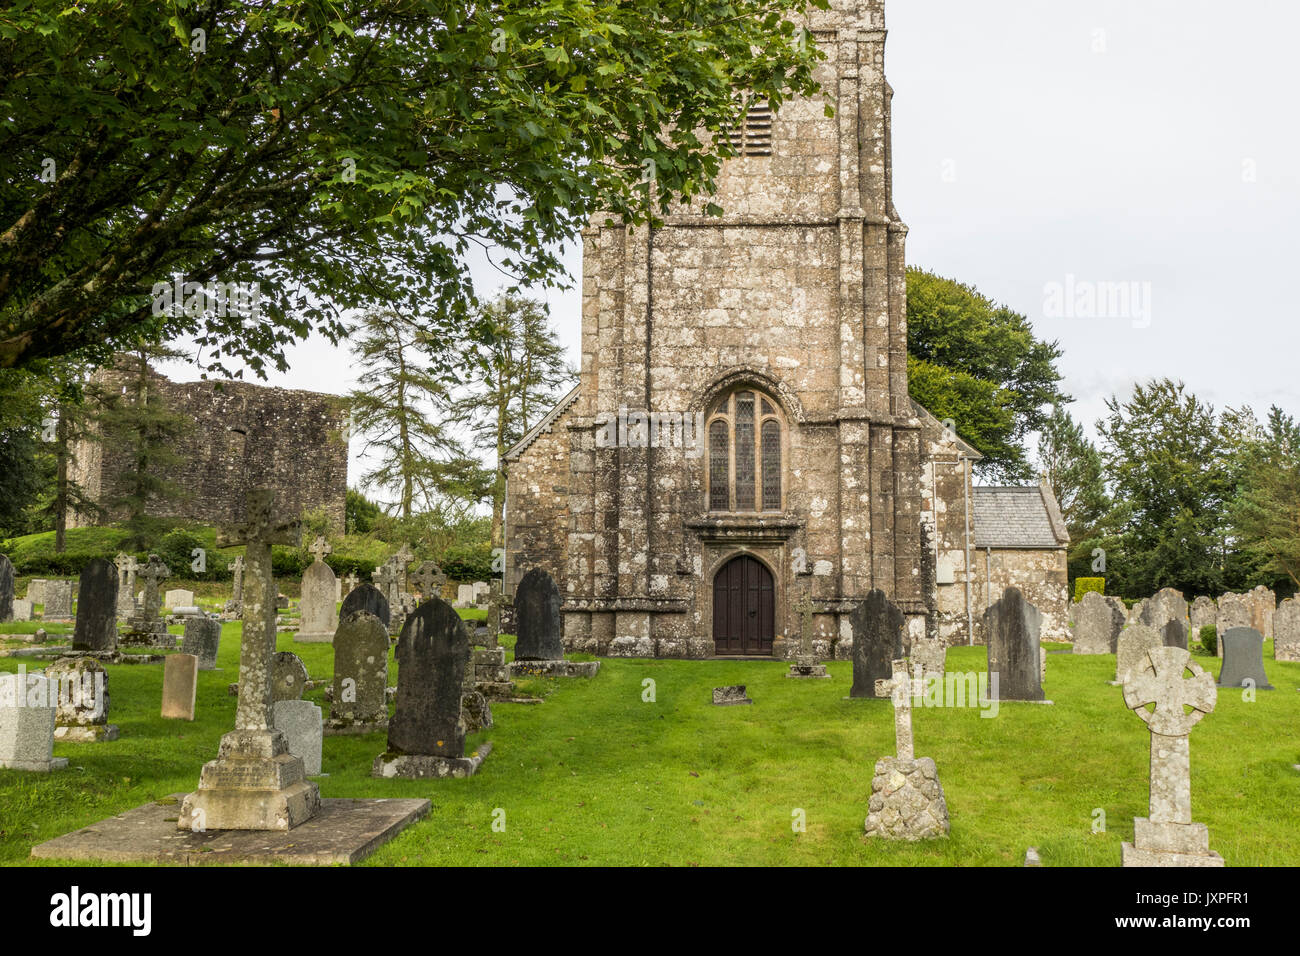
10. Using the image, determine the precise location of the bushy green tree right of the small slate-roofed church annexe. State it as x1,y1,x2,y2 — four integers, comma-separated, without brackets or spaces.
1097,378,1235,597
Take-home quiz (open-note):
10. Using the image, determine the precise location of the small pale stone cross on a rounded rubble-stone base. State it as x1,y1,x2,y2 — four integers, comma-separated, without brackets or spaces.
865,659,950,842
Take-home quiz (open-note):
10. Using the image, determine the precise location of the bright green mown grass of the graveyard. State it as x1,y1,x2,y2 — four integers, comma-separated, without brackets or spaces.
0,615,1300,866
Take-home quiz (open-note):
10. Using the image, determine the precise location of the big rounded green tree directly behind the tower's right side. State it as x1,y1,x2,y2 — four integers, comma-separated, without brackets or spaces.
907,268,1070,481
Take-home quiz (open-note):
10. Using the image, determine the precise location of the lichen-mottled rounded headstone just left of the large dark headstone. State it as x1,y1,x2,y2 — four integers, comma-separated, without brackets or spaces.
325,611,389,734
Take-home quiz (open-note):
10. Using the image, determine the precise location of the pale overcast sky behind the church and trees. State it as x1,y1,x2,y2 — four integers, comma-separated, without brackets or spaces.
164,0,1300,484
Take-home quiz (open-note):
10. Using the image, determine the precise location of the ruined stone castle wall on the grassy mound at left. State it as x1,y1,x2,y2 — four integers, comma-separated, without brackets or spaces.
73,369,347,531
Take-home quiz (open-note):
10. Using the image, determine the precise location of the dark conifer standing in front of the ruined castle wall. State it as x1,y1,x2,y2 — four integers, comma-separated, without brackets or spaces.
87,342,194,550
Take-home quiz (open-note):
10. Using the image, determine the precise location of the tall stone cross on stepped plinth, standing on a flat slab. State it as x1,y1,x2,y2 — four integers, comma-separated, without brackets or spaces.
177,490,321,830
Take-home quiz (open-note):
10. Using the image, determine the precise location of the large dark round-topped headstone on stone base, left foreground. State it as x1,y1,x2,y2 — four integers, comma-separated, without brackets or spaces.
389,597,469,757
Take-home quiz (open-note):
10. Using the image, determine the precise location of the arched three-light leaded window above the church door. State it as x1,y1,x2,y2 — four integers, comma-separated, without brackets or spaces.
709,389,785,511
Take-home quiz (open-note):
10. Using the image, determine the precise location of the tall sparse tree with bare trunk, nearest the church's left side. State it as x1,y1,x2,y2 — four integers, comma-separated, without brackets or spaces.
449,291,577,548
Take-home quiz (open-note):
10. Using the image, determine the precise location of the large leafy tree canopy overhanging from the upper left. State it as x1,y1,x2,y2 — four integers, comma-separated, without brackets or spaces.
0,0,826,372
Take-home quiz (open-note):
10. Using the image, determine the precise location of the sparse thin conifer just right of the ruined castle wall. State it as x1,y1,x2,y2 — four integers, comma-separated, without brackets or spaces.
350,306,488,519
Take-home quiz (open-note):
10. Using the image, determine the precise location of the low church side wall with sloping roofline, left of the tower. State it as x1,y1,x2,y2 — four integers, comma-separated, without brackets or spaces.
506,412,569,594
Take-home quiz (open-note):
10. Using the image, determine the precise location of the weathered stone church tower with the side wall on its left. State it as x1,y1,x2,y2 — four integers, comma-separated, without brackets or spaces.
506,0,933,658
